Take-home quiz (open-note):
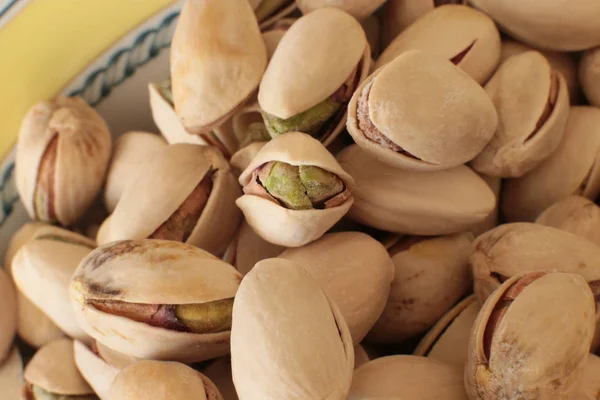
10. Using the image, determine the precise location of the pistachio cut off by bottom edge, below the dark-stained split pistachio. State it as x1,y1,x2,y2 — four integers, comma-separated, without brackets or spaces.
109,360,223,400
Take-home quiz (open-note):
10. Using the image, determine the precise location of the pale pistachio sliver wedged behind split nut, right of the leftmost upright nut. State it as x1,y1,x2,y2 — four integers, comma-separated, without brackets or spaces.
104,131,166,213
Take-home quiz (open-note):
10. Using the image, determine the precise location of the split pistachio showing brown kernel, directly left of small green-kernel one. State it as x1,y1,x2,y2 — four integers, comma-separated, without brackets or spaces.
98,143,241,255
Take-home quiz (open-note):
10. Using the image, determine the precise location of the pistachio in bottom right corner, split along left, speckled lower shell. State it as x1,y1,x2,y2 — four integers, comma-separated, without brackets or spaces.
465,271,596,400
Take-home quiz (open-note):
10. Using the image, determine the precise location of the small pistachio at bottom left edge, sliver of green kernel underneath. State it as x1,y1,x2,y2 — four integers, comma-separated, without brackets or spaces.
23,339,98,400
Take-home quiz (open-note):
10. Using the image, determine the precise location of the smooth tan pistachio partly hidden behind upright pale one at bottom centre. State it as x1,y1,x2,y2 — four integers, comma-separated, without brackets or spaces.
279,232,394,344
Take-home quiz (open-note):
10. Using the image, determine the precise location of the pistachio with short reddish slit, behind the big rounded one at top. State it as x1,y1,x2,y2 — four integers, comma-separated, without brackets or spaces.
375,5,500,84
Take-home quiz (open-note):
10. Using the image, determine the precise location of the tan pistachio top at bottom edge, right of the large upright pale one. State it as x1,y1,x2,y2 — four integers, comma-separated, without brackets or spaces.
348,355,467,400
